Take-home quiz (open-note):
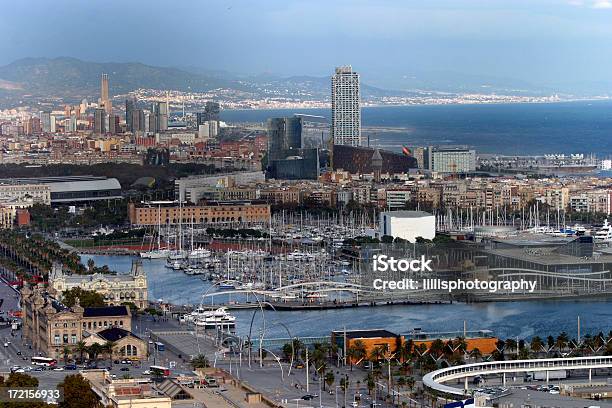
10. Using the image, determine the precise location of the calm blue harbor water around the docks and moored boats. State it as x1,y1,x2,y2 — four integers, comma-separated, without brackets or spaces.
82,255,612,338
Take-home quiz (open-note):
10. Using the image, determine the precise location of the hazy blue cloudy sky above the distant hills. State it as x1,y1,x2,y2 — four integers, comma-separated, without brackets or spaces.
0,0,612,89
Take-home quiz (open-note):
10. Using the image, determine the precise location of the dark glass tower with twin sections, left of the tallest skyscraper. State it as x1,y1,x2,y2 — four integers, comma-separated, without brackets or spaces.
268,117,302,160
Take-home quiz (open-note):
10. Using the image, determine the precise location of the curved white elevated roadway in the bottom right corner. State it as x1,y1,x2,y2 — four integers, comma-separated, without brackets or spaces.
423,356,612,399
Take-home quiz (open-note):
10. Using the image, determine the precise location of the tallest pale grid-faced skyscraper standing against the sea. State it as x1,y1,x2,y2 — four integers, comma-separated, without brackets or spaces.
331,65,361,146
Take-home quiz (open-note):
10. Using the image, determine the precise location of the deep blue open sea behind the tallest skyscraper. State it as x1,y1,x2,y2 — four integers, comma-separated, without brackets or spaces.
221,101,612,158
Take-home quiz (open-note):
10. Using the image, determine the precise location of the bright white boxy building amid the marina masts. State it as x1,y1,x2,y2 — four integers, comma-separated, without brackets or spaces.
379,211,436,242
